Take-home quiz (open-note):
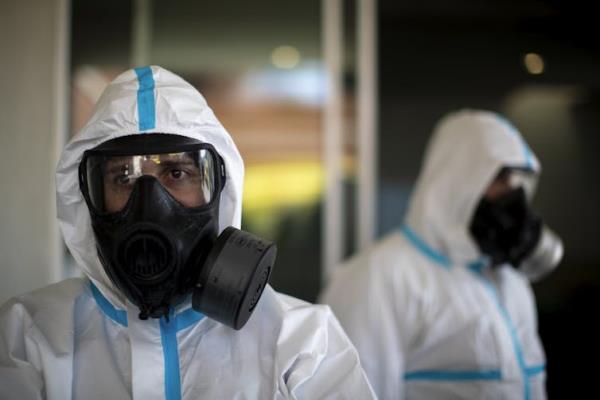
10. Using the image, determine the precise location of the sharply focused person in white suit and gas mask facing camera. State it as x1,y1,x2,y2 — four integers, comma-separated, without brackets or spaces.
0,66,374,400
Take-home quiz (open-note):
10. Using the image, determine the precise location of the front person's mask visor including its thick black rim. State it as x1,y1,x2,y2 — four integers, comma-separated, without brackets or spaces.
79,134,225,214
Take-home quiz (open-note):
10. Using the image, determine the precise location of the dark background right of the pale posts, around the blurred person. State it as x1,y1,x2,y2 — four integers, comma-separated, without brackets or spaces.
379,0,600,399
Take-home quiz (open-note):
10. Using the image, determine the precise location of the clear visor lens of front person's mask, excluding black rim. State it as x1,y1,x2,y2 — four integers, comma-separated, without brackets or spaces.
85,149,216,213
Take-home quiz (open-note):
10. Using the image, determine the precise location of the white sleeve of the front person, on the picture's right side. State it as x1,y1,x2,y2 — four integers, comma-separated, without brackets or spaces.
277,305,375,399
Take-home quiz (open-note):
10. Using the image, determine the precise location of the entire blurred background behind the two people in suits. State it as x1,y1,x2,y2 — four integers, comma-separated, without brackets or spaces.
0,0,600,399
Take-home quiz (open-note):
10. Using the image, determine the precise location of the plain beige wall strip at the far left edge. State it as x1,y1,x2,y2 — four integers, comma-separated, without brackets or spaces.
0,0,70,302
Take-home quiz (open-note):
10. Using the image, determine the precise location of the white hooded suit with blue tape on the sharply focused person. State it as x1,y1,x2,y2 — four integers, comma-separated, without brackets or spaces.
0,66,373,400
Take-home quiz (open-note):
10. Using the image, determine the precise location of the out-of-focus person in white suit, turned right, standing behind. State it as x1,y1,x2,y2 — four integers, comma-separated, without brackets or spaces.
320,110,562,399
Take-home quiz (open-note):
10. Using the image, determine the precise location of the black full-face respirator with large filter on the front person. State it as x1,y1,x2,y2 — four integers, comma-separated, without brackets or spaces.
79,134,277,329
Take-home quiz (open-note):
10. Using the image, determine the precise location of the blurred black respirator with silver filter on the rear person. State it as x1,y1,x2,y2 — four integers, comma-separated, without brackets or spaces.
469,169,563,281
